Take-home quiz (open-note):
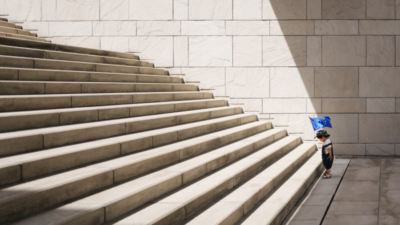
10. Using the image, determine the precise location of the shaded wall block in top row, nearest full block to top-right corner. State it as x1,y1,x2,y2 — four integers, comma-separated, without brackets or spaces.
367,0,396,19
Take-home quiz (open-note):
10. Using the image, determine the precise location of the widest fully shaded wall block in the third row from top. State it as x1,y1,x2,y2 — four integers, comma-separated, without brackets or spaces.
322,36,366,66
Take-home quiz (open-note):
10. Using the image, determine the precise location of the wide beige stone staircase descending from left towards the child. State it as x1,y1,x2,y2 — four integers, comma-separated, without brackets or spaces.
0,19,322,225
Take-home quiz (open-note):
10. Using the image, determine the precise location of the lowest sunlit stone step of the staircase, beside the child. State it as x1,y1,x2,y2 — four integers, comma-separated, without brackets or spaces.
242,153,323,225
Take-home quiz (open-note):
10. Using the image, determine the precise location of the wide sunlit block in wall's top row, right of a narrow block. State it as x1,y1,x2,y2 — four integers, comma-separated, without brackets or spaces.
189,0,232,20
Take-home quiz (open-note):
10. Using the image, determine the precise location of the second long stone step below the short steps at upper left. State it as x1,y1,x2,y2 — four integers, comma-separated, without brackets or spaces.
0,45,154,68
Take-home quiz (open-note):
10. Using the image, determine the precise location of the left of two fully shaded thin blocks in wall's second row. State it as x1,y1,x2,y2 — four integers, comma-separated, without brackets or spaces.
315,20,358,35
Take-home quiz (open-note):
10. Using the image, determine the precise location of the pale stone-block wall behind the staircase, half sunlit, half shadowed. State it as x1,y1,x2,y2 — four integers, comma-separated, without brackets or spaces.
0,0,400,155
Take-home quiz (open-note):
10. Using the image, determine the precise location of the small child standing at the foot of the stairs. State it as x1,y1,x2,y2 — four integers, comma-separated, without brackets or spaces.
316,130,334,179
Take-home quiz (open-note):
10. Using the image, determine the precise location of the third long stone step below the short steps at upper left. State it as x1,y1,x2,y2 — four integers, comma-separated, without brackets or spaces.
0,56,168,75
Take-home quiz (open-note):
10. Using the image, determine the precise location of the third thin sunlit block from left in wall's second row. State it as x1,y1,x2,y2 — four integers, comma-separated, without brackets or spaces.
93,21,139,36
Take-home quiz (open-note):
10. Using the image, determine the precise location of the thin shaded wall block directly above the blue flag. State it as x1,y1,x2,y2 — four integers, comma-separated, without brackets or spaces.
322,98,366,113
